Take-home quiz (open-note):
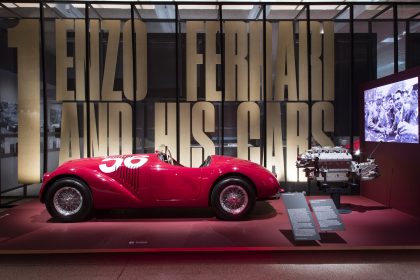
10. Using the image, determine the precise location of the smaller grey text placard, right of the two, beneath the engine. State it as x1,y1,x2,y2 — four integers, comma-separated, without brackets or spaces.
309,199,345,231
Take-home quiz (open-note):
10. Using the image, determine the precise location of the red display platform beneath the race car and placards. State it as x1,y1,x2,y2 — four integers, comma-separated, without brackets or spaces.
0,196,420,254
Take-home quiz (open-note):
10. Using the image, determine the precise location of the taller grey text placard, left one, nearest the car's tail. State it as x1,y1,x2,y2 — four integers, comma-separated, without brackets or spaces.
281,193,321,240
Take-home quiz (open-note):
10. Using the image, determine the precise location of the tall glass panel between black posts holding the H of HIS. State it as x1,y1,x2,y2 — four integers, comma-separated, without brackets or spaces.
136,5,177,157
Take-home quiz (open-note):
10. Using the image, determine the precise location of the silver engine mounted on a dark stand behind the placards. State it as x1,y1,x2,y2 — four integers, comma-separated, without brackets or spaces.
296,147,379,212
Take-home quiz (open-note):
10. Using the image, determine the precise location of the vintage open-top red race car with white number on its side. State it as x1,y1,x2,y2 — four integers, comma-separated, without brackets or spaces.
39,148,280,222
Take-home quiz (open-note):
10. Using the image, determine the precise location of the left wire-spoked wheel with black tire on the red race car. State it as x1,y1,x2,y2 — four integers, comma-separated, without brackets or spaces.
45,178,93,222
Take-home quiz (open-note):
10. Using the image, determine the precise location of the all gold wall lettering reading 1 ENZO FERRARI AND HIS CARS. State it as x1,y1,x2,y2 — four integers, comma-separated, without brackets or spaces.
8,19,334,183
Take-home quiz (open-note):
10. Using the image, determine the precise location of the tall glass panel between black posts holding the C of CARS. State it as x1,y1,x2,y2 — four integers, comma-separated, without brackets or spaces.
223,5,264,168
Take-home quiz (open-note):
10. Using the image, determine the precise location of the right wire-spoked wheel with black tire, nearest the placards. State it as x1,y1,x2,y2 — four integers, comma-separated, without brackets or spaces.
211,177,256,221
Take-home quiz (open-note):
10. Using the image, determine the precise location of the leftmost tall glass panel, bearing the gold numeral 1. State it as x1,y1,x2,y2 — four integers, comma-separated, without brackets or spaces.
0,4,40,197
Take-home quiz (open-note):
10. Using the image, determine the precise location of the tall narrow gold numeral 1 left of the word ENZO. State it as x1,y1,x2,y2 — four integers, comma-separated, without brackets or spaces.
8,19,41,184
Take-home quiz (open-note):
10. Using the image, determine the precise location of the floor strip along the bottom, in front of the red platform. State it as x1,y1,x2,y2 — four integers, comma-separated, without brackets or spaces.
0,250,420,280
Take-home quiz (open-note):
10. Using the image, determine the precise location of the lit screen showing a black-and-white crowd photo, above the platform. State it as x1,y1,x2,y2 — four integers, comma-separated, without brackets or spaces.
363,76,419,143
